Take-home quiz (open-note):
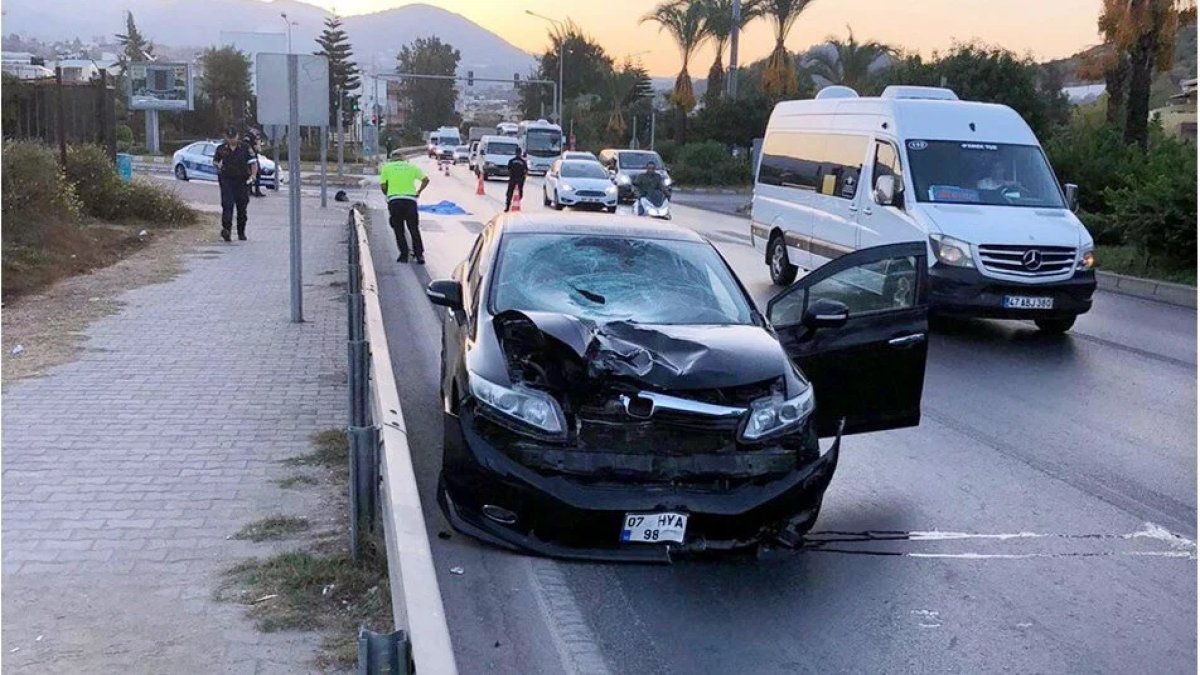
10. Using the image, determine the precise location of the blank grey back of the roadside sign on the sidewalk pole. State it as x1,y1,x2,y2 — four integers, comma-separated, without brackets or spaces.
254,53,329,126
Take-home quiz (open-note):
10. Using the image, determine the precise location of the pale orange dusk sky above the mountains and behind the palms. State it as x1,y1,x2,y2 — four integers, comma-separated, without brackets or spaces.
288,0,1100,77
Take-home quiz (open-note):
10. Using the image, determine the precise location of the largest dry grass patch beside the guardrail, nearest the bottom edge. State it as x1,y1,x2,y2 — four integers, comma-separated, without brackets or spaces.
217,533,392,669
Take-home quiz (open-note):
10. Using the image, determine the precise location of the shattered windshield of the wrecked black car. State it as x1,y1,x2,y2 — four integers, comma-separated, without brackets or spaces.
491,234,752,324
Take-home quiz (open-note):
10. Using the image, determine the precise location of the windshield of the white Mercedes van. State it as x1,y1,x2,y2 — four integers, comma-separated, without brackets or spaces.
905,139,1064,209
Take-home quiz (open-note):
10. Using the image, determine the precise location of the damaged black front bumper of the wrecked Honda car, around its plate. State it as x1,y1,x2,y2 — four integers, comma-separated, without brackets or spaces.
438,406,841,562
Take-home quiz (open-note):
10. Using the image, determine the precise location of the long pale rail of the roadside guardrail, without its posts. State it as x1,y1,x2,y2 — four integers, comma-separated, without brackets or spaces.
354,209,457,675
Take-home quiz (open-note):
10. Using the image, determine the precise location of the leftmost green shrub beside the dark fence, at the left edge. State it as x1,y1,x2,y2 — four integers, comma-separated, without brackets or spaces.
0,141,80,244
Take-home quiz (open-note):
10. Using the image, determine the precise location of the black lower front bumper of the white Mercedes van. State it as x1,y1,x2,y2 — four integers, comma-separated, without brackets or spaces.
929,264,1096,319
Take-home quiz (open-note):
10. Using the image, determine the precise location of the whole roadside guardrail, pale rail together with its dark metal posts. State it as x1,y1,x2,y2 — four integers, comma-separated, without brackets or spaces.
347,208,457,675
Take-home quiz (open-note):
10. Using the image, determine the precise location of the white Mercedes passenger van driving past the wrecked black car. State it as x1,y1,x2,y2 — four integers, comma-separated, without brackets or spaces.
750,86,1096,333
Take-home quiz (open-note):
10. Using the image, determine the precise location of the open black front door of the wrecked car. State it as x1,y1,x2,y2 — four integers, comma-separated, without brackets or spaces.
767,241,929,437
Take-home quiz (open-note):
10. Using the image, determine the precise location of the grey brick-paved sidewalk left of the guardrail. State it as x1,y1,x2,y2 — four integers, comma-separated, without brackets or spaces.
2,195,347,674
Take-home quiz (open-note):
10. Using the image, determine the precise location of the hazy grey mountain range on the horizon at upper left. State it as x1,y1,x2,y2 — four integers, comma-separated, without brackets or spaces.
4,0,534,79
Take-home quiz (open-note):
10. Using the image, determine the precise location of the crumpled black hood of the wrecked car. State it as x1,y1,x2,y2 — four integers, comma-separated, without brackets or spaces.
494,306,791,390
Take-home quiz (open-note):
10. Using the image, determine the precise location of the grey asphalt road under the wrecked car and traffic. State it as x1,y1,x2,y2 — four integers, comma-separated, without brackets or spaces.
356,160,1196,674
